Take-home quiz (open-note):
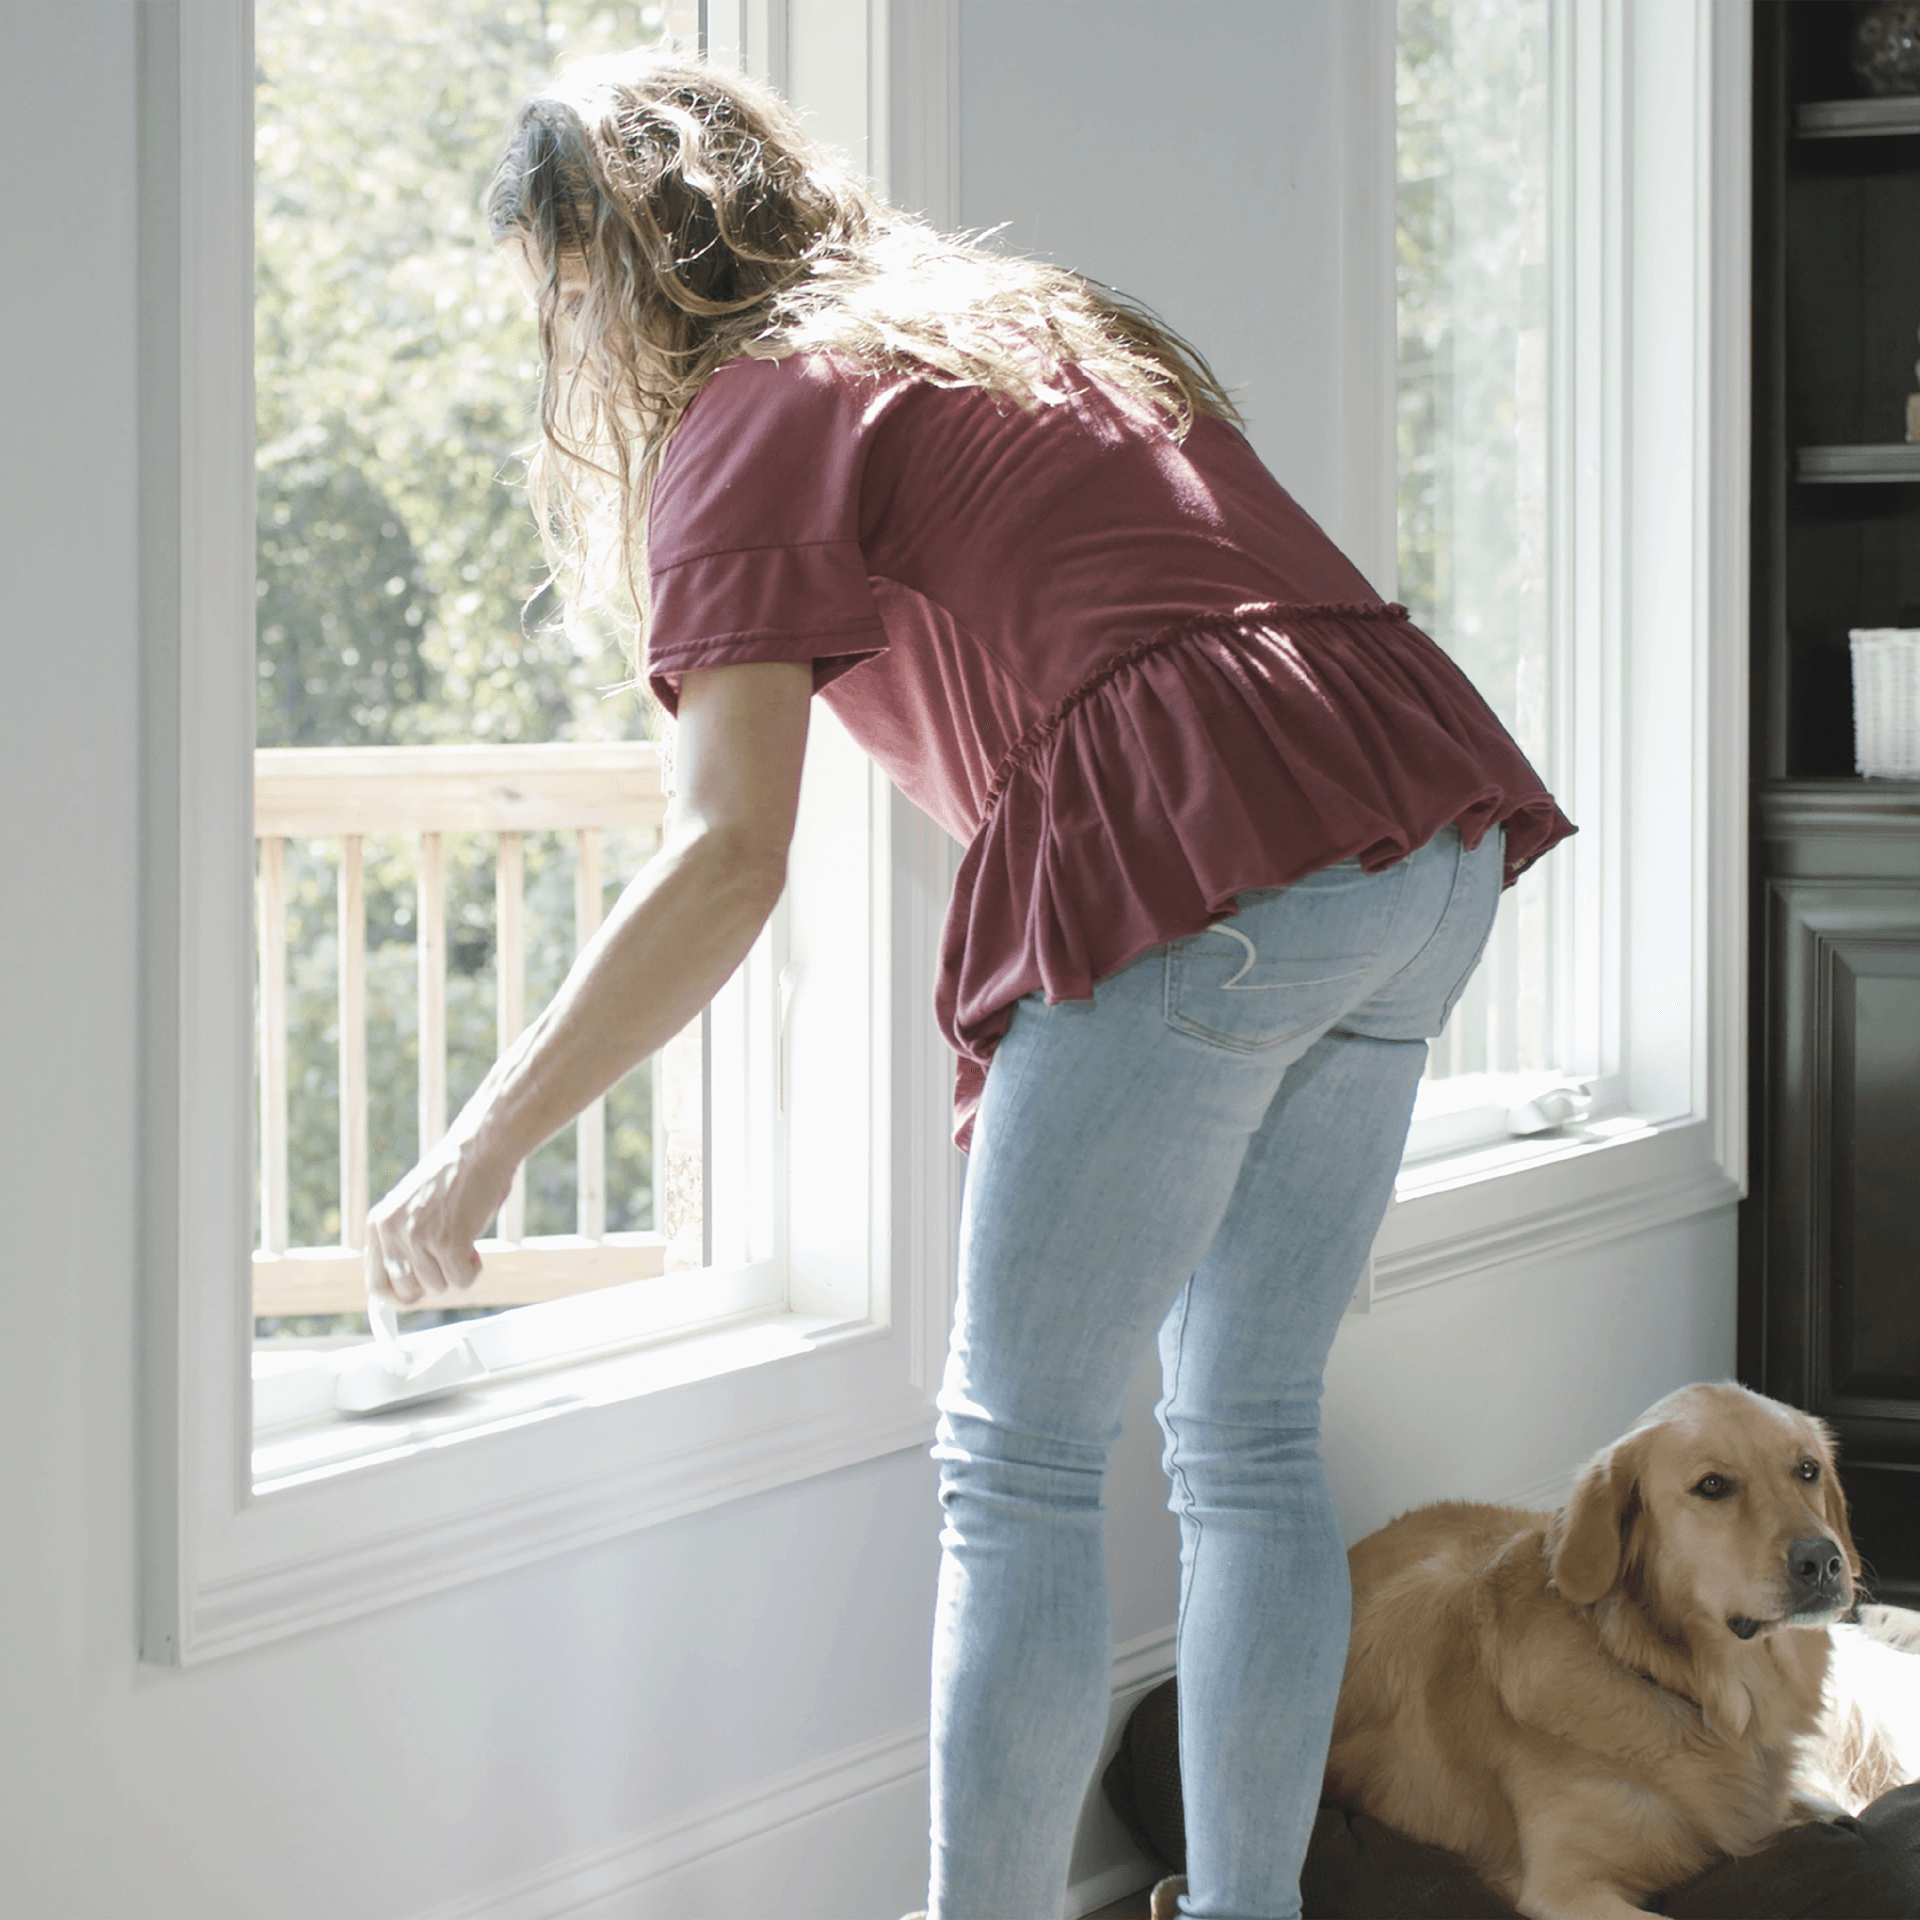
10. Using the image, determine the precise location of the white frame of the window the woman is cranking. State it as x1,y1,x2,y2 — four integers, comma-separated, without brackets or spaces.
140,0,960,1665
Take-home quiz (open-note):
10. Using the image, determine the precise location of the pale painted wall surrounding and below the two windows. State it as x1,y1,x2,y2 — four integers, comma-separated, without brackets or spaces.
0,0,1734,1920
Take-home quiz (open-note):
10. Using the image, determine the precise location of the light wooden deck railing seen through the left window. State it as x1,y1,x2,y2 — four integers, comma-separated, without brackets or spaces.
253,743,703,1315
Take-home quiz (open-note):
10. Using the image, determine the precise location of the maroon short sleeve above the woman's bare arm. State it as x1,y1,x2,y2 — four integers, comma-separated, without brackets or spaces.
647,355,887,712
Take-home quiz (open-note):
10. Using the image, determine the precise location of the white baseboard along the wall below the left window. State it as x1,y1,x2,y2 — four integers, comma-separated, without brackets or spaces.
415,1628,1173,1920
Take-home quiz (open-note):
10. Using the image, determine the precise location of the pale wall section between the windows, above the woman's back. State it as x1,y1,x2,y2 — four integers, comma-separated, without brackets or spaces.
958,0,1392,572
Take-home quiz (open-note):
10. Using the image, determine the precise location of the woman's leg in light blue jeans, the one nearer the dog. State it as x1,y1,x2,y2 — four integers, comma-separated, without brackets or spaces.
1158,1033,1427,1920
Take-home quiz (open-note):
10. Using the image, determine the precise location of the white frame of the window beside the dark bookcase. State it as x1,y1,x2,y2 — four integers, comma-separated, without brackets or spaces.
1348,0,1751,1309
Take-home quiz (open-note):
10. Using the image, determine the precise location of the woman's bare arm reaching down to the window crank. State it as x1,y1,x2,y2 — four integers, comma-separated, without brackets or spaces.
367,662,812,1306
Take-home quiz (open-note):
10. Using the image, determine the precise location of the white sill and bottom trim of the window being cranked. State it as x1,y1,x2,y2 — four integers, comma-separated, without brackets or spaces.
183,1313,933,1663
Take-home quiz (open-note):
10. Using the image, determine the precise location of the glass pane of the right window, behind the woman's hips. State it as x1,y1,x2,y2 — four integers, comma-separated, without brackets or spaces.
1396,0,1553,1079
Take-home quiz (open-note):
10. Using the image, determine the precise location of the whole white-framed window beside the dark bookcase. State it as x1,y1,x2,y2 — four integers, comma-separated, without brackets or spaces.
1371,0,1749,1298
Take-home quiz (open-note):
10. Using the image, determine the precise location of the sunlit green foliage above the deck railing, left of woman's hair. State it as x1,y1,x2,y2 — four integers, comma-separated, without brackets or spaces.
255,0,657,745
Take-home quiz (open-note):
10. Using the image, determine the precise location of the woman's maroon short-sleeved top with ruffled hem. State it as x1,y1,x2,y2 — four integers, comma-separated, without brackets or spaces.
649,353,1572,1144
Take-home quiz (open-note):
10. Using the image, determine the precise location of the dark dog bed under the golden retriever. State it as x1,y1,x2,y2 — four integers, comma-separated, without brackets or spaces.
1102,1680,1920,1920
